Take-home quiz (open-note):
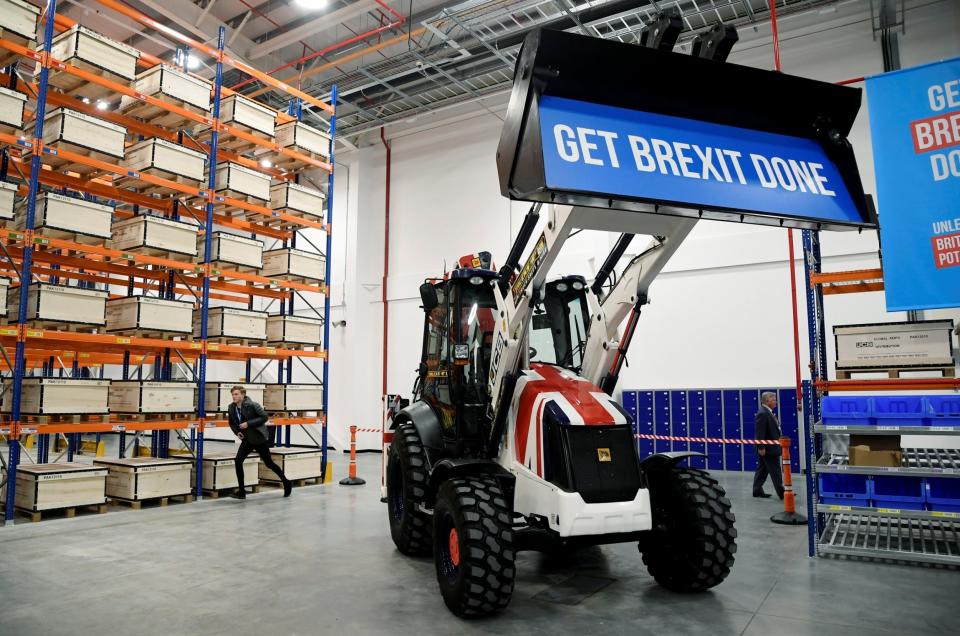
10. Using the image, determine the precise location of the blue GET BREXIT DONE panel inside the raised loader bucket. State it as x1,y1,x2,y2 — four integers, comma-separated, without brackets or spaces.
540,95,863,224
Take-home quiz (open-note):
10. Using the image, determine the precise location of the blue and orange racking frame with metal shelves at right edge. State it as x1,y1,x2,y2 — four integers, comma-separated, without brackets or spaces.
803,230,960,566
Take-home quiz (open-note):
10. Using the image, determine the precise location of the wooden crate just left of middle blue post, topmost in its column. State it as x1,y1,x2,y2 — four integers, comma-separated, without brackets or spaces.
120,64,212,113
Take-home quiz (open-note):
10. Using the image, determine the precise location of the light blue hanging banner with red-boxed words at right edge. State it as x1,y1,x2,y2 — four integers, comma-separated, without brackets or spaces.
867,58,960,311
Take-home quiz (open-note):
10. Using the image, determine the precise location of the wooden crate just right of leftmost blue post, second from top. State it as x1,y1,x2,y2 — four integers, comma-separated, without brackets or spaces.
43,108,127,159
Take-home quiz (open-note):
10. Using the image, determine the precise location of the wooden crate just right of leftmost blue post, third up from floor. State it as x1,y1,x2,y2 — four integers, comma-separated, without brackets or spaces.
7,283,107,327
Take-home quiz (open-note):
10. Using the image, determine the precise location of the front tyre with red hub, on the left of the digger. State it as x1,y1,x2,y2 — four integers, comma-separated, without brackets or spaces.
433,475,515,618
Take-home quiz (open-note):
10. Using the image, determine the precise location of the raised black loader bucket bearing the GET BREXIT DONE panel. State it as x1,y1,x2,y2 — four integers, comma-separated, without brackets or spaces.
497,30,877,230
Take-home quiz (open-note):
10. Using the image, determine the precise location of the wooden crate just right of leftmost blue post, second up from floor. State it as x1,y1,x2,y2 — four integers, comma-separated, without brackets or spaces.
0,378,110,415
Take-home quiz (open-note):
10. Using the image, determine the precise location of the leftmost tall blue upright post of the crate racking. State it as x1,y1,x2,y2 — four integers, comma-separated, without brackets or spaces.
4,0,57,521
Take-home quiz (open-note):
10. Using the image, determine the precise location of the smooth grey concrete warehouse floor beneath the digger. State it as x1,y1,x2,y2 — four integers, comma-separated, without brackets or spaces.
0,455,960,636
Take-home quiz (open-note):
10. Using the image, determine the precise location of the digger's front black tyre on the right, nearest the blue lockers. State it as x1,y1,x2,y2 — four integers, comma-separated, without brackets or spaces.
639,467,737,593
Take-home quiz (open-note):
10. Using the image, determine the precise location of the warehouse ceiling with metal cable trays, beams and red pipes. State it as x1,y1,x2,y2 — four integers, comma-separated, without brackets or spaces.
59,0,903,143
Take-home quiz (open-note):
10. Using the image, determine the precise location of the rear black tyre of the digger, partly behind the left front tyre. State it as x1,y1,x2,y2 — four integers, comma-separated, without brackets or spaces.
387,422,431,556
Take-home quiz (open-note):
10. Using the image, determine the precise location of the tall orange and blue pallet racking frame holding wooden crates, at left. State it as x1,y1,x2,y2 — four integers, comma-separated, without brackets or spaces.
0,0,337,520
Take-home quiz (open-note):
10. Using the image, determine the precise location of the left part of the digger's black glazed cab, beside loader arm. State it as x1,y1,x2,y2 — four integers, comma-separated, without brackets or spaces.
418,252,497,456
